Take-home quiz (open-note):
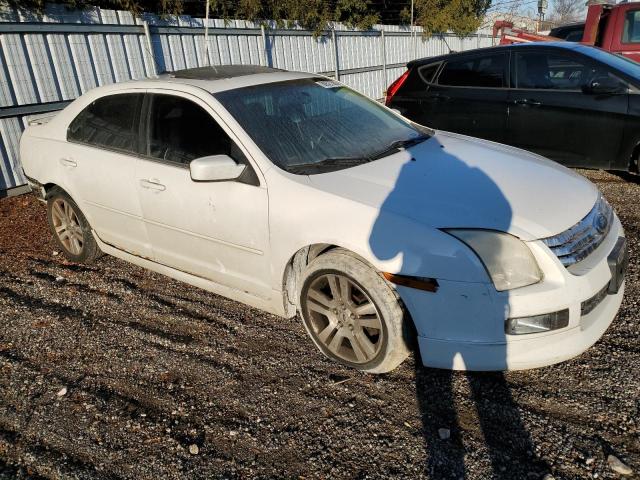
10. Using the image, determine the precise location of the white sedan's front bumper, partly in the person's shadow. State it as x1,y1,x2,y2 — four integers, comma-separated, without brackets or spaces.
398,217,624,370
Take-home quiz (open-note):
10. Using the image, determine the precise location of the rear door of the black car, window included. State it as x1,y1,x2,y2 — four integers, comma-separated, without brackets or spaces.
422,51,509,142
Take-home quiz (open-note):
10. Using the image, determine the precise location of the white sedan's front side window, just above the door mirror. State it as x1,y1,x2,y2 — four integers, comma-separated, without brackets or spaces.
147,95,238,165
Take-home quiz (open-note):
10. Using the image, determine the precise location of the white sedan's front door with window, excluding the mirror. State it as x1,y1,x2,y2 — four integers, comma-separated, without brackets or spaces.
136,93,271,299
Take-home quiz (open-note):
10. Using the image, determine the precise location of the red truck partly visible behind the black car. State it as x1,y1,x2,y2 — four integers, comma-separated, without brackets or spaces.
493,2,640,62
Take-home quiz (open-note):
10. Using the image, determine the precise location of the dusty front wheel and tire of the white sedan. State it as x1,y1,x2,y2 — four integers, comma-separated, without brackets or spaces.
298,249,411,373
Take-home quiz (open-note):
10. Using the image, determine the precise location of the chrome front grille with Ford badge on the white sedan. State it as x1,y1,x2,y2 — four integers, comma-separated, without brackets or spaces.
542,195,613,267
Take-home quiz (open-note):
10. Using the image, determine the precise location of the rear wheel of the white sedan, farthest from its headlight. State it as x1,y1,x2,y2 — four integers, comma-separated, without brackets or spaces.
47,188,102,263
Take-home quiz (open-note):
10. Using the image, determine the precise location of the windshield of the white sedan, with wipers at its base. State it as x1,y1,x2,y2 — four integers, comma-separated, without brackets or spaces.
215,78,430,174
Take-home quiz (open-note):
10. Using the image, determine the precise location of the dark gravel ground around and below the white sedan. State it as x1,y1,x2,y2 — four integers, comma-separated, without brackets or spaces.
0,171,640,480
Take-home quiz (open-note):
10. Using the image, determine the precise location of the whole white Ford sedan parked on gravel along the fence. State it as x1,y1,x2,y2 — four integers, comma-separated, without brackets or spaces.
20,66,627,373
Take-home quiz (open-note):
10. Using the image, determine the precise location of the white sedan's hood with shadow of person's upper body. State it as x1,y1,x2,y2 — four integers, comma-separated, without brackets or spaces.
309,131,598,240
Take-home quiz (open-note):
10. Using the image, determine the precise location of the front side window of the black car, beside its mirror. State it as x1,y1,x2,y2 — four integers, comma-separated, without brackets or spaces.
515,51,609,90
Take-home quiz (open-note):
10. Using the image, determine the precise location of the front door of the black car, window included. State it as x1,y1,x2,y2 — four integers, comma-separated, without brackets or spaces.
506,47,628,168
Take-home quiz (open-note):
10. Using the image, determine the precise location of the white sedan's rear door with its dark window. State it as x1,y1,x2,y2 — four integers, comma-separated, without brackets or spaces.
64,93,150,257
